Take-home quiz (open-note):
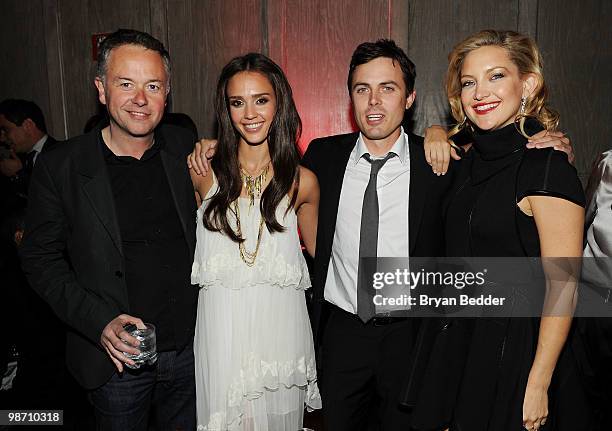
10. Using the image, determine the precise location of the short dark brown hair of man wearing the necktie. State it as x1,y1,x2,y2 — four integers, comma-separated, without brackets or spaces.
346,39,416,96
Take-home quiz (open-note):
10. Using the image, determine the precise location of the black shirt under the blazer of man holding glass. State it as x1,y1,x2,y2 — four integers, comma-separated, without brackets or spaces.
100,135,192,351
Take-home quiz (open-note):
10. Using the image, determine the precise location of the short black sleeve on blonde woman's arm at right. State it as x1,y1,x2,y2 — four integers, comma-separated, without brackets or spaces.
516,148,585,207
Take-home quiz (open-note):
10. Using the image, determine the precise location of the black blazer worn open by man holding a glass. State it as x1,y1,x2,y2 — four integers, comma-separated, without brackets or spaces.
21,126,197,389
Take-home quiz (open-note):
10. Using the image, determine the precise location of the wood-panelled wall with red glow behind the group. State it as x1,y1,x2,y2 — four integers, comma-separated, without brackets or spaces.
0,0,612,181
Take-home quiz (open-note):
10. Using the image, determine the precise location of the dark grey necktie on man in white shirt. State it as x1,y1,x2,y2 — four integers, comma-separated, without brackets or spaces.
357,153,395,323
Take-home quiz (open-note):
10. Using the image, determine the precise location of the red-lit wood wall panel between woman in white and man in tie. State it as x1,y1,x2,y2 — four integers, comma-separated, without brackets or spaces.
268,0,400,151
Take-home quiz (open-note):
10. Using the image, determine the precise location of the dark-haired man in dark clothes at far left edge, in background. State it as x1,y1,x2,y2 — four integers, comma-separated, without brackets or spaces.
0,99,67,414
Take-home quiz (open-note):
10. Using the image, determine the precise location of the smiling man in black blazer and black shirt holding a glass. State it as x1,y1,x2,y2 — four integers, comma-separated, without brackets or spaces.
21,30,197,430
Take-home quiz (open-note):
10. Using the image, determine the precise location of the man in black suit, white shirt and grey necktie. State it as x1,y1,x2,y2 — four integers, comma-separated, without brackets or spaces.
302,40,452,431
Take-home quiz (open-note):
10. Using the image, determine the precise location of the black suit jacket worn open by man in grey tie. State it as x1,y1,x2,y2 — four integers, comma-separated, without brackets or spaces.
302,133,455,412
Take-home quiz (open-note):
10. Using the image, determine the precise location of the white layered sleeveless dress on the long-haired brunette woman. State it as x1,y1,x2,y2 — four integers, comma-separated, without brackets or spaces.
191,178,321,431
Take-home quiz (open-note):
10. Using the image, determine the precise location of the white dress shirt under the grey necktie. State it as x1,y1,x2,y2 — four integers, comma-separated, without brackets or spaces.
325,129,410,314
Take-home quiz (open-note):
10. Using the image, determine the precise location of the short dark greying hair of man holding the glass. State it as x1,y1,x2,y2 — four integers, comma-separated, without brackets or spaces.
96,28,170,79
